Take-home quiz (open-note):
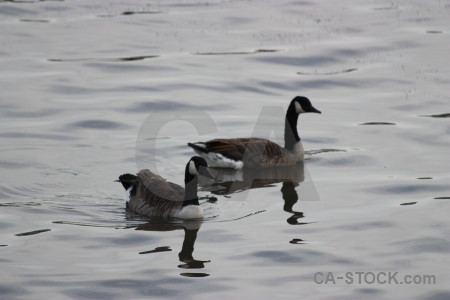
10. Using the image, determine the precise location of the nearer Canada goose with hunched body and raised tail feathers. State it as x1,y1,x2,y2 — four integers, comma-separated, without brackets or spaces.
117,156,214,219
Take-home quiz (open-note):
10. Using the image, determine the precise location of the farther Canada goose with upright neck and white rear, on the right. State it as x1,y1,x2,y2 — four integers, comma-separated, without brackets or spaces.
188,96,321,169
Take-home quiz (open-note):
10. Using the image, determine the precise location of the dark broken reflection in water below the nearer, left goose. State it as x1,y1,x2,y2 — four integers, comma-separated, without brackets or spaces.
136,220,211,277
